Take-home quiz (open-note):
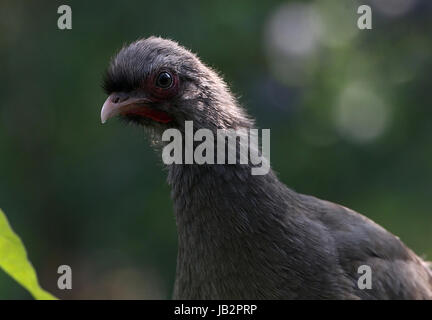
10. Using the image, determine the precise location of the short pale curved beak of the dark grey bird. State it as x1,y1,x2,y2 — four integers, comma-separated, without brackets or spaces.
101,92,149,123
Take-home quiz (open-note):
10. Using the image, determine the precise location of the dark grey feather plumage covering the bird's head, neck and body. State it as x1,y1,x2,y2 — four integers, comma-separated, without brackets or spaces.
100,37,432,299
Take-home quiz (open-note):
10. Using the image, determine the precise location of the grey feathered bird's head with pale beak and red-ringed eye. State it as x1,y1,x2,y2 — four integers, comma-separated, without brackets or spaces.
101,37,251,135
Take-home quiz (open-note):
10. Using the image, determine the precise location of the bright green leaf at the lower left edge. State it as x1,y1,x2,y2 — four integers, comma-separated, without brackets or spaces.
0,209,57,300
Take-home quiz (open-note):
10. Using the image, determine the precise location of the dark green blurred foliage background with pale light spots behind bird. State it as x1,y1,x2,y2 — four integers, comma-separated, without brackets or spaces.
0,0,432,299
